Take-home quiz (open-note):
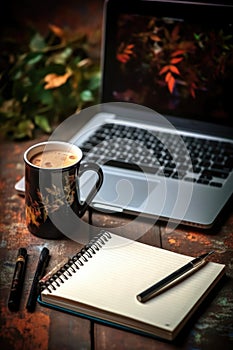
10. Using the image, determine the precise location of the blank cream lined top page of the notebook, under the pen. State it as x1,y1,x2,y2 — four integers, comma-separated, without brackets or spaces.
43,234,226,331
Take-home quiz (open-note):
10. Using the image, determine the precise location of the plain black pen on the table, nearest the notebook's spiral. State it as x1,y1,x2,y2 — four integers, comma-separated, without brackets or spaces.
26,248,50,312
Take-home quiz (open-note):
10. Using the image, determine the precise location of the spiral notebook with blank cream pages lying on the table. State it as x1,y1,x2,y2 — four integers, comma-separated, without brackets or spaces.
38,231,224,340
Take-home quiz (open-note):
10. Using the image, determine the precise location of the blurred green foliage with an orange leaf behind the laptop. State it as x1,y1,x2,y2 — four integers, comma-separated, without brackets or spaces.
0,25,100,139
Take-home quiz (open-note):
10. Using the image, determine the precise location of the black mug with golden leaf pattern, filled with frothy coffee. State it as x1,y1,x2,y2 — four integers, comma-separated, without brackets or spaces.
24,141,103,239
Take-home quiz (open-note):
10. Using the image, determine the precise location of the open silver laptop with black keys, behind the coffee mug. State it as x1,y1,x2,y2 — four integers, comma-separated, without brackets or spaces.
16,0,233,229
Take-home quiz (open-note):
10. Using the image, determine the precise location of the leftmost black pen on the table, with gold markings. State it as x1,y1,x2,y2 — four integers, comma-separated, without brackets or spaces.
8,248,27,311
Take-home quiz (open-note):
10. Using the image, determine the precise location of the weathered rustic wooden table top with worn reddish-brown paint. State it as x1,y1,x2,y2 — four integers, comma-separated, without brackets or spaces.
0,136,233,350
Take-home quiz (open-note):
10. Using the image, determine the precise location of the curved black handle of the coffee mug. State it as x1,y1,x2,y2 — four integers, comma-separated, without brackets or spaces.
78,163,104,217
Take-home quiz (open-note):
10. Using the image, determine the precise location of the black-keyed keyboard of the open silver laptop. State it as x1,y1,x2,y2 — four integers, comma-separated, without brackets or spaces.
80,123,233,187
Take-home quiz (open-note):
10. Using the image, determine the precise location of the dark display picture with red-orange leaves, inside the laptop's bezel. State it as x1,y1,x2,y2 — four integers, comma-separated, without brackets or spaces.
104,4,233,126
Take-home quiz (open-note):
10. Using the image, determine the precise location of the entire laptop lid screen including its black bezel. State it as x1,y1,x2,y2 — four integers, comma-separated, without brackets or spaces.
102,1,233,126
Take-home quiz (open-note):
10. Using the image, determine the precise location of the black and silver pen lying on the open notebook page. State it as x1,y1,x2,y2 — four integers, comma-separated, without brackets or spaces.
136,251,214,303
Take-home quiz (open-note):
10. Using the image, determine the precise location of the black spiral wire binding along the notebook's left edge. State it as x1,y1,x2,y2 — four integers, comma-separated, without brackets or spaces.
40,230,111,293
